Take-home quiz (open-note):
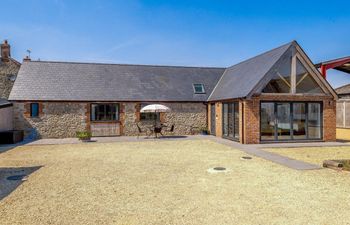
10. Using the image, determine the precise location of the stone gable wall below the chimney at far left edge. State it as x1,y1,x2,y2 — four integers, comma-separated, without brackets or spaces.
0,59,20,99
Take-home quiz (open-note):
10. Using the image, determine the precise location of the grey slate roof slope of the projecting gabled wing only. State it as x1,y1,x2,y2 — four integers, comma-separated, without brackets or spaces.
209,42,293,101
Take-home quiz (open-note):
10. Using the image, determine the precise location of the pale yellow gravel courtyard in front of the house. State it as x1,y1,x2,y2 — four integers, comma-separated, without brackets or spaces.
0,140,350,225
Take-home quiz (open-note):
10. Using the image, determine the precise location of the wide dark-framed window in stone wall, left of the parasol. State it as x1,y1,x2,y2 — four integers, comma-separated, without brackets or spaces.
91,104,119,121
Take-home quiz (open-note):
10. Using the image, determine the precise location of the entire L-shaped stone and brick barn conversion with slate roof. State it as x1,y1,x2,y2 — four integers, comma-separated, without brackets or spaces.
10,41,337,144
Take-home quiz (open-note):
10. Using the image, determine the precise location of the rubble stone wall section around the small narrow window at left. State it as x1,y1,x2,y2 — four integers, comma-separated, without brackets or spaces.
13,102,88,138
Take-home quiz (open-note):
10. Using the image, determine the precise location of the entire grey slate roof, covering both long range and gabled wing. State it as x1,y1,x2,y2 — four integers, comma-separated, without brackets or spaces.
9,41,332,102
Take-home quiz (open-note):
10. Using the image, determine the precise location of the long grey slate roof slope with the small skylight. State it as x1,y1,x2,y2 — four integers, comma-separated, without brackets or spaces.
9,61,225,102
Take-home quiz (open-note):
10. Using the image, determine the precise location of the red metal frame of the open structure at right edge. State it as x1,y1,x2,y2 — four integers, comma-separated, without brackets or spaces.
315,56,350,78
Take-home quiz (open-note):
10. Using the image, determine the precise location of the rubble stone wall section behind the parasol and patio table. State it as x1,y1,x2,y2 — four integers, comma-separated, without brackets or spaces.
122,103,207,136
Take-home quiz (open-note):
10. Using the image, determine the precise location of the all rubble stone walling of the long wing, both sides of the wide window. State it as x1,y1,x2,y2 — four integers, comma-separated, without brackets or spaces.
13,102,207,138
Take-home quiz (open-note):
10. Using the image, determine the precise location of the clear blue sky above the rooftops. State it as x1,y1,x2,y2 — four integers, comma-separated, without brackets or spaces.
0,0,350,88
